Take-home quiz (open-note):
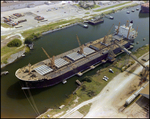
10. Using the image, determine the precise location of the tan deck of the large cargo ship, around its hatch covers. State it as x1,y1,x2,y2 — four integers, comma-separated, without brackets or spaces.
16,35,128,81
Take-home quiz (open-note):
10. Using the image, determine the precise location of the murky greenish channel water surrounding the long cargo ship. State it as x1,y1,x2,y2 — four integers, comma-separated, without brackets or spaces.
1,6,149,118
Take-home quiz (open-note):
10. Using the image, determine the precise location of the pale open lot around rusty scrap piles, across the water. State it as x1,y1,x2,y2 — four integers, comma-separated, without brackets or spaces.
1,4,83,35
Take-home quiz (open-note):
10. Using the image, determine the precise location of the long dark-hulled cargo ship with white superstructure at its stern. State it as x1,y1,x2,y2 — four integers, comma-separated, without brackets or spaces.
15,21,137,89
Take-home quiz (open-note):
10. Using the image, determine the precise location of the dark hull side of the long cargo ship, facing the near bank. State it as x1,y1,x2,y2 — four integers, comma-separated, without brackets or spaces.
20,42,131,89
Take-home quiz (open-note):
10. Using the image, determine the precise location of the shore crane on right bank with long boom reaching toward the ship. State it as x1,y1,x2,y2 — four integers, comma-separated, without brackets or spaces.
112,39,149,79
